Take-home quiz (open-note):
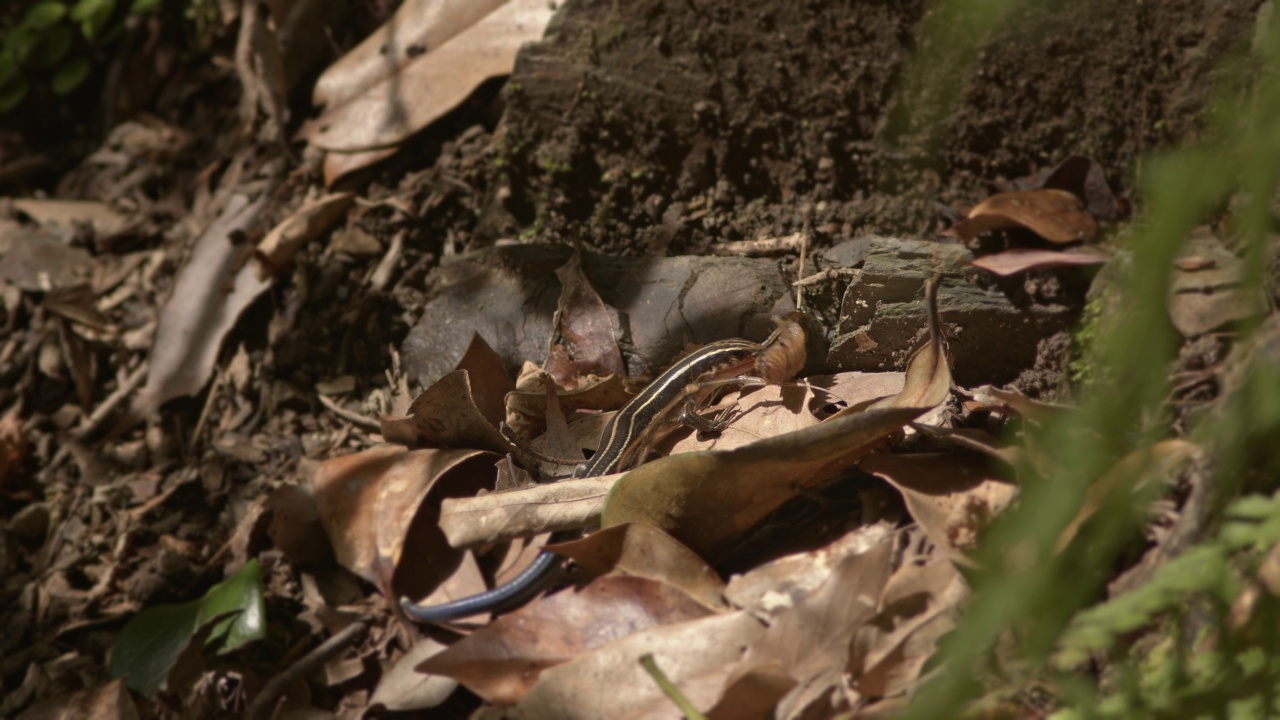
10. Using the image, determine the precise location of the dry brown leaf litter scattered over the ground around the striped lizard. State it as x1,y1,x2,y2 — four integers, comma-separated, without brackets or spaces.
0,3,1274,717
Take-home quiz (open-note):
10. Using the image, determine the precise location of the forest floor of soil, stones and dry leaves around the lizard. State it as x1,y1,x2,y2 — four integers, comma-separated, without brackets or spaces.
0,0,1275,717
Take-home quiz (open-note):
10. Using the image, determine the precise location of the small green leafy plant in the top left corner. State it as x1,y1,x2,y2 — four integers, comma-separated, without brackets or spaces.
0,0,160,113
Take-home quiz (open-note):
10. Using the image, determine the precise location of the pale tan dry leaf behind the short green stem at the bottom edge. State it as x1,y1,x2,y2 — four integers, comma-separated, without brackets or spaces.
515,604,763,720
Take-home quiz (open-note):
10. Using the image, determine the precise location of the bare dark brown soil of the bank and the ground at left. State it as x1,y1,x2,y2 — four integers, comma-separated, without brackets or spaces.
0,0,1261,715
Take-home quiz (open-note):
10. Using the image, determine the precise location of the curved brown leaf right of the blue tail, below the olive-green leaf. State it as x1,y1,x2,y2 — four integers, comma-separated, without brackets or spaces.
549,524,728,610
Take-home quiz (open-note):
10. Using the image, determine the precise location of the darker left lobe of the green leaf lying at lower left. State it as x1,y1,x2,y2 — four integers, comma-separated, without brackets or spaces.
111,600,201,694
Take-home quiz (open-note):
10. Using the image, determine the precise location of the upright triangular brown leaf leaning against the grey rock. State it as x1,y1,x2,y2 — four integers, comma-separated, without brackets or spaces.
544,251,626,389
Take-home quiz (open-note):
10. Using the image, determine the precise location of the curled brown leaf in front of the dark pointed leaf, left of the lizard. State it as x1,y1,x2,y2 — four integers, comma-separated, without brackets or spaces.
383,370,515,455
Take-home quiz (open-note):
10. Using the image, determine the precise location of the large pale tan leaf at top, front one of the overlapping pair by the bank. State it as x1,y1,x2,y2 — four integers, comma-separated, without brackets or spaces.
298,0,554,152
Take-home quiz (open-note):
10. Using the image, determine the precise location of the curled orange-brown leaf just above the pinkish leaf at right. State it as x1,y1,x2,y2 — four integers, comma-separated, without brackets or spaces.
946,188,1098,243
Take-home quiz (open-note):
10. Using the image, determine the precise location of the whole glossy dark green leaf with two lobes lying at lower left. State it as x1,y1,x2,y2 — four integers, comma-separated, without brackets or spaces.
111,560,266,694
